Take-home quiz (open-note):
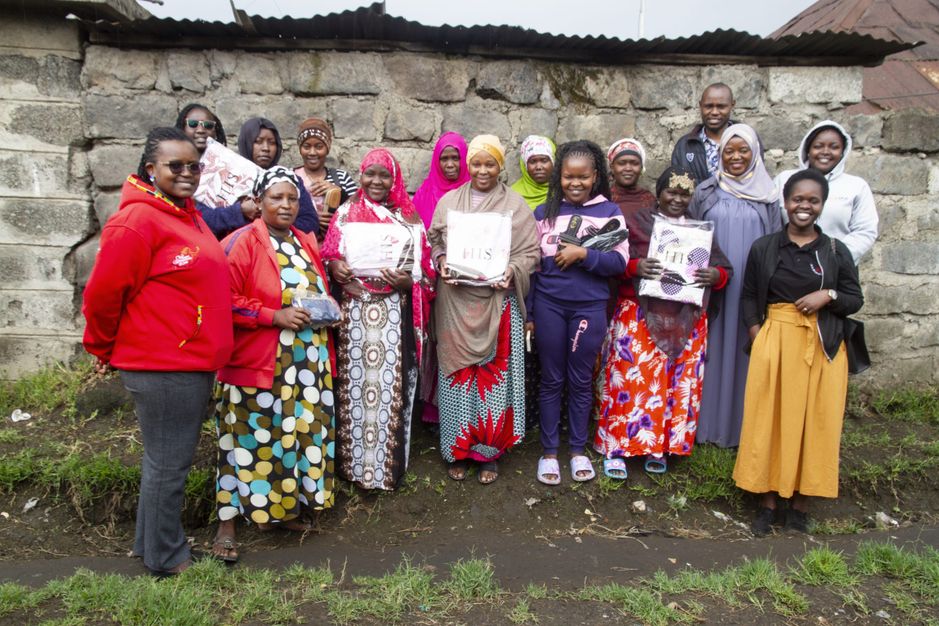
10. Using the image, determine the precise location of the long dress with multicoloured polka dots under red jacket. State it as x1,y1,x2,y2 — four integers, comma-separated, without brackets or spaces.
216,236,336,524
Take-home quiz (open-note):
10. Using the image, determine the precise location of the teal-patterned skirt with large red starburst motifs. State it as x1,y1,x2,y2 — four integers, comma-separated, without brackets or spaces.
437,294,525,463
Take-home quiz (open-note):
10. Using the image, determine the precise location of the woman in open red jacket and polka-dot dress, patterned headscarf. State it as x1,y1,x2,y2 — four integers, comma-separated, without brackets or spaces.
212,167,338,562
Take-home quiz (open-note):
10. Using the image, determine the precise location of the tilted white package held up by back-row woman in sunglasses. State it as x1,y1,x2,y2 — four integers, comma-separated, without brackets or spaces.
194,137,262,207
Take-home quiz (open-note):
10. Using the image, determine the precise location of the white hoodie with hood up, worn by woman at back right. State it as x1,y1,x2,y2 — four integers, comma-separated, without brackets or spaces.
775,120,877,263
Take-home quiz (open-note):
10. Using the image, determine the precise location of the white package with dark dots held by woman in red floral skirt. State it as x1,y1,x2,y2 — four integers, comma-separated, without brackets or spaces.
639,215,714,306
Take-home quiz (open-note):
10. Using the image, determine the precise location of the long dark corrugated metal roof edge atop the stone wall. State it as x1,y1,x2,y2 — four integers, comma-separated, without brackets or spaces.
77,5,912,65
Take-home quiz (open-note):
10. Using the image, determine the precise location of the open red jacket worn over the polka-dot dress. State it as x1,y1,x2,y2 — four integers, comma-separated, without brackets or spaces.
218,219,336,389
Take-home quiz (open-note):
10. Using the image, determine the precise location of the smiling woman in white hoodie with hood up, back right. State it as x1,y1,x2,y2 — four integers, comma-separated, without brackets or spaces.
776,120,878,264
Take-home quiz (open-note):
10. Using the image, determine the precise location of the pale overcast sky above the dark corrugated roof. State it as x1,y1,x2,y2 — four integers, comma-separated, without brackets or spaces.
137,0,813,39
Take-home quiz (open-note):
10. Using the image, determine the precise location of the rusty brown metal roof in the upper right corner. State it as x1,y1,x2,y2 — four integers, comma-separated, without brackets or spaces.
770,0,939,110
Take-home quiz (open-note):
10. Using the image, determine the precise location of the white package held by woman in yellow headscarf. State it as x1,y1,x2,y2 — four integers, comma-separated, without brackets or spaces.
447,211,512,285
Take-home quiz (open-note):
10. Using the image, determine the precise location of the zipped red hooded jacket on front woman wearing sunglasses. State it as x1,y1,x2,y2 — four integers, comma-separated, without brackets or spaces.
82,176,232,372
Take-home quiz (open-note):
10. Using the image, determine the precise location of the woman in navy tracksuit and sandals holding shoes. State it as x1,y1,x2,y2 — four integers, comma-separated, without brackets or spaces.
528,141,629,485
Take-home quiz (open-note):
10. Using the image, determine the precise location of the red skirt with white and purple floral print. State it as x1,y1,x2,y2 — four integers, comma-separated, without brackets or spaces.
593,300,707,458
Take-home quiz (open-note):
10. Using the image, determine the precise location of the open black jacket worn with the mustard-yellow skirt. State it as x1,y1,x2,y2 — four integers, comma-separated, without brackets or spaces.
740,226,864,360
